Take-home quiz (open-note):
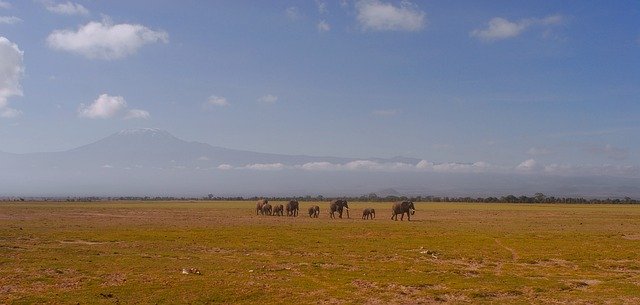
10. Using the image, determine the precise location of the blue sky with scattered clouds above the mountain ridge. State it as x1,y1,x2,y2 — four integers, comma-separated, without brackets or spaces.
0,0,640,177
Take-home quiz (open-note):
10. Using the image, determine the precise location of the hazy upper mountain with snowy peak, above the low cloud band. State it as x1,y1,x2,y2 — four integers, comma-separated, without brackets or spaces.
0,128,384,170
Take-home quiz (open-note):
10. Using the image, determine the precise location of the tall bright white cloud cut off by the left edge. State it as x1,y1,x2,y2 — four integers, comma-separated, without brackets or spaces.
0,36,24,118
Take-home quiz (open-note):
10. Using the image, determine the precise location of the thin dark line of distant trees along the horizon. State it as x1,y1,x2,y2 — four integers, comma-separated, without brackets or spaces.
0,193,640,204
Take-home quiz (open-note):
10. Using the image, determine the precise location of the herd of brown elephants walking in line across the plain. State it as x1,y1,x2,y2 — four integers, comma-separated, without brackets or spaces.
256,199,416,221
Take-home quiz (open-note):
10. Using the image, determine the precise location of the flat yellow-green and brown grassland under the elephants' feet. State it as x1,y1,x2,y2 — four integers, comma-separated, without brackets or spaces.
0,202,640,304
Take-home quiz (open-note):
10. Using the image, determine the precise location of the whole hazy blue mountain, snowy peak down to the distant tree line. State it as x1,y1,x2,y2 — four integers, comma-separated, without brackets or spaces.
0,128,640,197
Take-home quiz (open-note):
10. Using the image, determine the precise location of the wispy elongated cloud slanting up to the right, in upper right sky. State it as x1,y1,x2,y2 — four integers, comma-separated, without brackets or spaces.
469,15,564,42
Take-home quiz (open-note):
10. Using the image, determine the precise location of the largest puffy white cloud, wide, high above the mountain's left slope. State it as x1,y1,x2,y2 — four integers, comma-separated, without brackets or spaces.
47,19,169,60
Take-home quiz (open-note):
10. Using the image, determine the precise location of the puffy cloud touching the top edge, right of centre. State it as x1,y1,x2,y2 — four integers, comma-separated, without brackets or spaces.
356,0,427,31
